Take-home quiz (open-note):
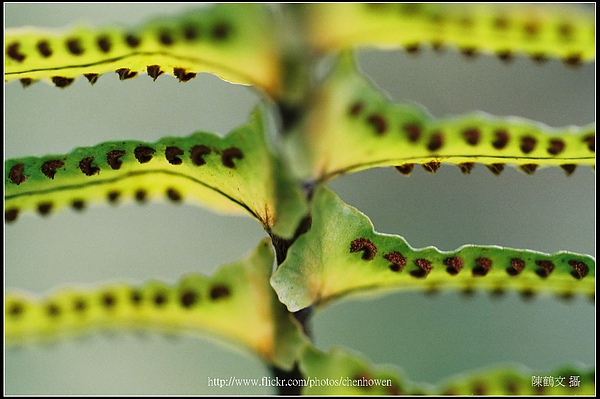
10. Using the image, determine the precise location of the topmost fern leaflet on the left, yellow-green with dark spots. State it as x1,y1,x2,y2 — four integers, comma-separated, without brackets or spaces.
4,4,280,95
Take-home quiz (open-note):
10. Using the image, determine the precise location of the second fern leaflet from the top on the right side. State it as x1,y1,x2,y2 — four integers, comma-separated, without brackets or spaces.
285,52,596,181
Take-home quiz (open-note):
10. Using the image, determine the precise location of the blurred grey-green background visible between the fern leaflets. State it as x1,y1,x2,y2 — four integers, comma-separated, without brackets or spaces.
5,3,595,395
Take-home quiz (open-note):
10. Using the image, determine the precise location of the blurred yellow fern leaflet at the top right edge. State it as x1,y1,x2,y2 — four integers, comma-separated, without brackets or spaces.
305,3,596,65
